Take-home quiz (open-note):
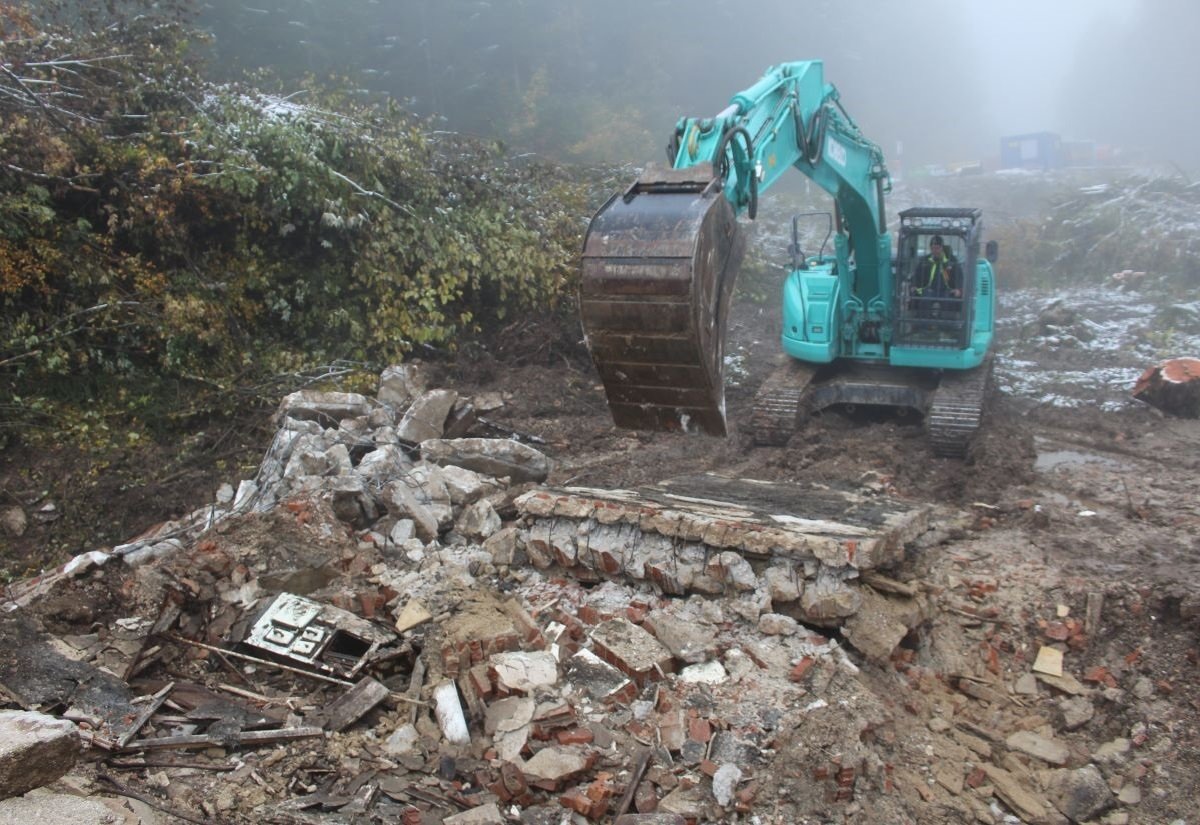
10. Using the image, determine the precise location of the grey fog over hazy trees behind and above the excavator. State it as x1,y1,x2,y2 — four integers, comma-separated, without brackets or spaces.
202,0,1200,171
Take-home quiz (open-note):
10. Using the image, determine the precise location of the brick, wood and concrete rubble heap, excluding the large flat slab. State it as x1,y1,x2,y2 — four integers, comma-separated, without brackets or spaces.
0,368,912,823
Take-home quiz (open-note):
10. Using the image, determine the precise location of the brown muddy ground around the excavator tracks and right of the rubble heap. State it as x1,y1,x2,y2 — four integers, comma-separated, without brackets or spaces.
420,268,1200,823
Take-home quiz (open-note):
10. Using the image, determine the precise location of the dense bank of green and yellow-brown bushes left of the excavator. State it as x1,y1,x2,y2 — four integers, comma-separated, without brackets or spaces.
0,1,600,450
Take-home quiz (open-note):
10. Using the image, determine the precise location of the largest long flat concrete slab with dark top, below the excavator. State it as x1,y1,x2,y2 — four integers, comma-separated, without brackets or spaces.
516,474,931,661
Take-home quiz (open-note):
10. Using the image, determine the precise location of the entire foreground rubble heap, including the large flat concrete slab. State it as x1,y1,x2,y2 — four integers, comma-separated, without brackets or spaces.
0,367,1195,825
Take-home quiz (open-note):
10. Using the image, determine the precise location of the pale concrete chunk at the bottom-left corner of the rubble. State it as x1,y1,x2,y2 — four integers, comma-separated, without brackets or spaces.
0,710,80,799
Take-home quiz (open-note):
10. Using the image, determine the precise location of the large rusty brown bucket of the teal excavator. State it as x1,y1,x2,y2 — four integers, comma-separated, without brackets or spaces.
580,163,745,435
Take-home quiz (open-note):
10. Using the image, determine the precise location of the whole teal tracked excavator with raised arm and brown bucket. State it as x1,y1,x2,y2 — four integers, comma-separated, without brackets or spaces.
580,60,997,458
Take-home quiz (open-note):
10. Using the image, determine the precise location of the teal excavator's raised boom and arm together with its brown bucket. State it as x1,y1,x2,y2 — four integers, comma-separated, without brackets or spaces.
580,60,890,435
